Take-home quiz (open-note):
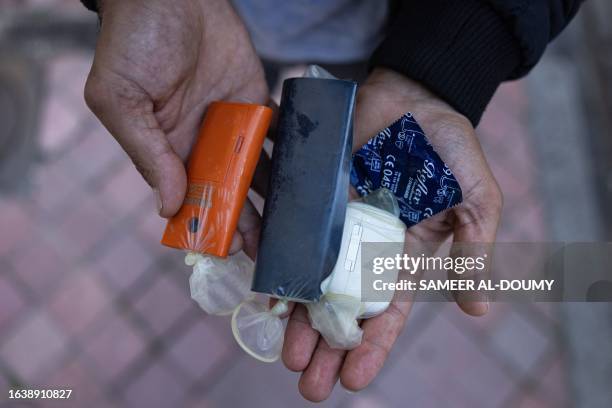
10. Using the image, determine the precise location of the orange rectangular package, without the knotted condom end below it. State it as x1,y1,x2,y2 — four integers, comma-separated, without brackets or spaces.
161,102,272,257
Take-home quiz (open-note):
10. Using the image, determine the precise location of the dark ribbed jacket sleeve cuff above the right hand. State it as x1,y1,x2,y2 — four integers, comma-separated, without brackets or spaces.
371,0,583,125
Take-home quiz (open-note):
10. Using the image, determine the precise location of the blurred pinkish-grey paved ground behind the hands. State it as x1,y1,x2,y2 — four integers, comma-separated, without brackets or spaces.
0,1,604,407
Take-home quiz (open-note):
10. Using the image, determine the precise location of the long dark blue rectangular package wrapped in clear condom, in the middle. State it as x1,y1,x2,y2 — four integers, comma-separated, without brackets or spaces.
252,78,357,302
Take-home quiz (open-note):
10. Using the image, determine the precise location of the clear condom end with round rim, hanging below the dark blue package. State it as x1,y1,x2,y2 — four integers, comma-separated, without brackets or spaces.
232,299,288,363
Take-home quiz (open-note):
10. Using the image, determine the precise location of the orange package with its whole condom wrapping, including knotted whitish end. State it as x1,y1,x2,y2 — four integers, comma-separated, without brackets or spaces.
161,102,272,314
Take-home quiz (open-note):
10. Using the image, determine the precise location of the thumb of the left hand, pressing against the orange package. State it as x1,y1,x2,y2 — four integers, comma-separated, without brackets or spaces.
85,72,187,218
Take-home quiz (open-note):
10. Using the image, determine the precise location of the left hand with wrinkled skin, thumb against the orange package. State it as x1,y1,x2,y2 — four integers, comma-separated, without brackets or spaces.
85,0,268,256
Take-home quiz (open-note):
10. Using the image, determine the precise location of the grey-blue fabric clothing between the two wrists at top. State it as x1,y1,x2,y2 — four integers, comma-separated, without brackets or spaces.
233,0,388,63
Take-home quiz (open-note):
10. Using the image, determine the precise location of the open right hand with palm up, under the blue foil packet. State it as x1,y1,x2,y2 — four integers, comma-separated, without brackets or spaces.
282,68,502,401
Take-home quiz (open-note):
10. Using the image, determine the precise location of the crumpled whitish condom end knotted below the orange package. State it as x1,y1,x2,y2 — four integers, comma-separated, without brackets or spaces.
185,251,254,315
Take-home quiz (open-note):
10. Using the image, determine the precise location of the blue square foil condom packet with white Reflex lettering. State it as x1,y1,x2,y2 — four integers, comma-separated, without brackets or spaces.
351,113,462,228
